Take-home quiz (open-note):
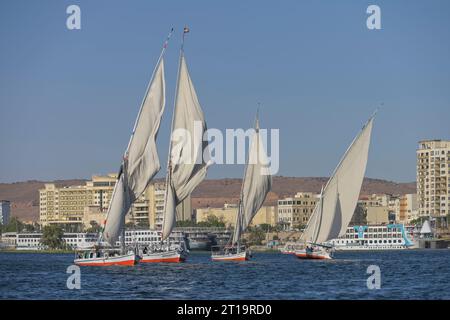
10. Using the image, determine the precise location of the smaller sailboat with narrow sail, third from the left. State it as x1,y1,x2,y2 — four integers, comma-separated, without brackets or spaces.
211,115,272,261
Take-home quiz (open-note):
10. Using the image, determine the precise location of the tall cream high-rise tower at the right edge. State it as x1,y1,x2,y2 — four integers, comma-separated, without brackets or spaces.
417,140,450,226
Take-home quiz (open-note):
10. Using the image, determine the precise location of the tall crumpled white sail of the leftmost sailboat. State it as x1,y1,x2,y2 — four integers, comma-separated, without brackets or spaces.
103,55,165,245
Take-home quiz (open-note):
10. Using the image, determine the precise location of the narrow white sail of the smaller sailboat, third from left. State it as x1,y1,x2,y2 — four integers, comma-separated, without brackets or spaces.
233,119,272,244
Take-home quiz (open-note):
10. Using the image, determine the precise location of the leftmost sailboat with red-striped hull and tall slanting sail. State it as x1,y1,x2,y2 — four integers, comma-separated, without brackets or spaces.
74,29,173,266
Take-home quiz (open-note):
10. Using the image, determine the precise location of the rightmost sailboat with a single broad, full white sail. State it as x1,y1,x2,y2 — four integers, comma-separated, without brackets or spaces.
295,114,375,259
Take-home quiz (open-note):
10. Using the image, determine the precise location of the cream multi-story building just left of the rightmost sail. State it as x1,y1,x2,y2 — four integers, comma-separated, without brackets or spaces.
278,192,318,229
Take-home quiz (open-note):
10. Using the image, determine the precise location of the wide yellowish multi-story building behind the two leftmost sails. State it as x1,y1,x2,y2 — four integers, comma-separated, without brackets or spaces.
39,174,191,229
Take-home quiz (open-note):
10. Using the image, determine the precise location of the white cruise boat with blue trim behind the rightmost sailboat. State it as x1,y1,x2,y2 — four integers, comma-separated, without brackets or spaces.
328,224,414,251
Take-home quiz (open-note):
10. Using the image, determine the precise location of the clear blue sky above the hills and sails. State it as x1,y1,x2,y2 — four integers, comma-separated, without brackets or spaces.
0,0,450,182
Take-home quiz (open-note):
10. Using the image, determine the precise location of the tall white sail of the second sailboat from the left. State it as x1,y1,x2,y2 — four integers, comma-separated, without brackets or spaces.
162,50,210,240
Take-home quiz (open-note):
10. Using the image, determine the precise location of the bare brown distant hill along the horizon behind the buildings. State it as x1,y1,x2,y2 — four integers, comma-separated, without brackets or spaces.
0,177,416,221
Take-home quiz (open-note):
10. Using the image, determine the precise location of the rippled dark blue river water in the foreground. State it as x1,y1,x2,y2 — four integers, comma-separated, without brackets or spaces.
0,250,450,299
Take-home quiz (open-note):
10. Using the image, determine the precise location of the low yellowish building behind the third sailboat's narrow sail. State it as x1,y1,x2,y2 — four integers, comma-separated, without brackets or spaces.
195,204,278,228
